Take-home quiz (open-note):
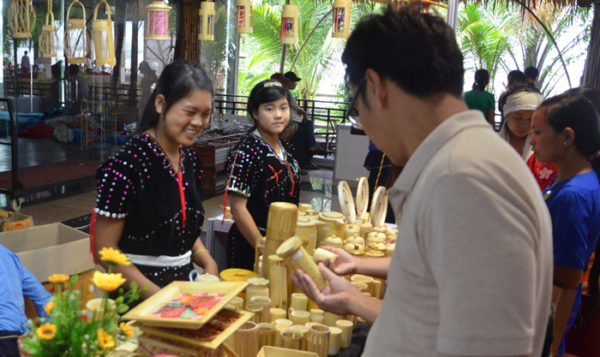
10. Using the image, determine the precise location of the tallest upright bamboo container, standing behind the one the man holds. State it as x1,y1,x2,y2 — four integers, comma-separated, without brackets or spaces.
264,202,298,279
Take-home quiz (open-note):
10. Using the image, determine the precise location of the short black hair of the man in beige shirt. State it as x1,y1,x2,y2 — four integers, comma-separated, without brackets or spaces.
342,5,464,98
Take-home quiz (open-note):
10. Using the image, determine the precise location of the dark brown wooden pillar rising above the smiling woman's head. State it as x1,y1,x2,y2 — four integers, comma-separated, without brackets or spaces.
175,0,200,63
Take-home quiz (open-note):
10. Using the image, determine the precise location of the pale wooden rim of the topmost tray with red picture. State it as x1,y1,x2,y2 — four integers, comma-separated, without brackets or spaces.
123,281,248,330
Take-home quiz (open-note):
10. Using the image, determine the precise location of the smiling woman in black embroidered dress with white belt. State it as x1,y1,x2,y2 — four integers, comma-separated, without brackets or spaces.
90,63,218,298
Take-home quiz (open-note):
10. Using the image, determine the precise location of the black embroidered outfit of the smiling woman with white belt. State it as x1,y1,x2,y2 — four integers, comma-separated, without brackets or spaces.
95,133,204,286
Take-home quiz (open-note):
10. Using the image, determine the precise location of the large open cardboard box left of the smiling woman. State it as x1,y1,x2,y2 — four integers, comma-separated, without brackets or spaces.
0,223,94,282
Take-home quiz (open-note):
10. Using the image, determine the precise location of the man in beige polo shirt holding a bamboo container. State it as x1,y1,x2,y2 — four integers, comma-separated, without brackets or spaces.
293,7,552,357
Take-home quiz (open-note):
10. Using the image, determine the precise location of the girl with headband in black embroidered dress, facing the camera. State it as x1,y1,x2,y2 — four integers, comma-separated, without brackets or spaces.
225,81,300,269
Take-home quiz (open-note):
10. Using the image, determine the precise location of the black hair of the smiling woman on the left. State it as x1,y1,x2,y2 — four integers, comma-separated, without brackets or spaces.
138,62,214,132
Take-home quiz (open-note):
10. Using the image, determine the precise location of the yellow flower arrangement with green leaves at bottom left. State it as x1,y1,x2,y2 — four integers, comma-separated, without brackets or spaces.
21,249,141,357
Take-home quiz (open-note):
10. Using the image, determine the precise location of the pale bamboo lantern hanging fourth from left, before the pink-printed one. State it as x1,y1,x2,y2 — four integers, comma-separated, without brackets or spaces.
92,0,117,67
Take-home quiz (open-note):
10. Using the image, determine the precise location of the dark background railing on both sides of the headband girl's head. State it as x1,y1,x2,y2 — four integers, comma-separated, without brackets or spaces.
215,95,349,156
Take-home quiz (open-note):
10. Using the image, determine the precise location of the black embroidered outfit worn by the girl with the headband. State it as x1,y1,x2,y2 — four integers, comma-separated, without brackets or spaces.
225,131,300,269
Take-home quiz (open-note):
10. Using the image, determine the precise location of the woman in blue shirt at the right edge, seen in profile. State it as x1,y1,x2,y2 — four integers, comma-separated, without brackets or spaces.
531,87,600,356
